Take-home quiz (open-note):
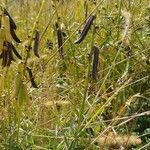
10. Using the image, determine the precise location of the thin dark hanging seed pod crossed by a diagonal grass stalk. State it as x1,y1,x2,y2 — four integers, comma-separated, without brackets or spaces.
56,23,64,59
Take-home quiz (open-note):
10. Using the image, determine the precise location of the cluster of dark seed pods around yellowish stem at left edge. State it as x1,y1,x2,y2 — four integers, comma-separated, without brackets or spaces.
0,8,22,67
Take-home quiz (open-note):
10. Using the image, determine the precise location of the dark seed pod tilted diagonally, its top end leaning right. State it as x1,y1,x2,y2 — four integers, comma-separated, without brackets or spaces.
75,15,95,44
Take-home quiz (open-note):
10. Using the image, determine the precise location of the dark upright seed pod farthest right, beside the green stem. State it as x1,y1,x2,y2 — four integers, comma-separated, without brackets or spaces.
92,46,99,80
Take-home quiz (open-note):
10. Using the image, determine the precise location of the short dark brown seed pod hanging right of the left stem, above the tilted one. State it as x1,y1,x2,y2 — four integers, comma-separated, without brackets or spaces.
33,30,40,57
